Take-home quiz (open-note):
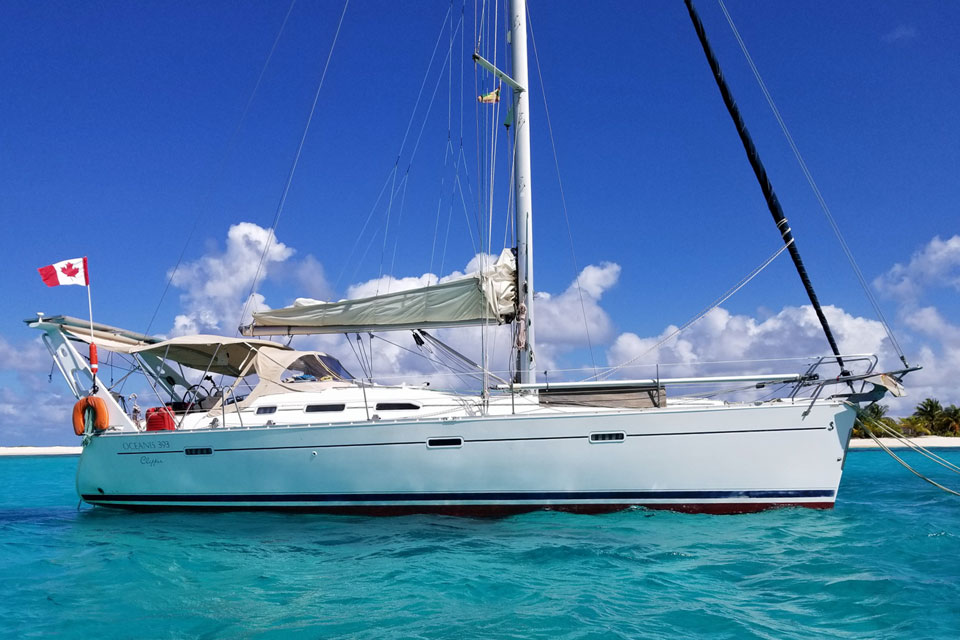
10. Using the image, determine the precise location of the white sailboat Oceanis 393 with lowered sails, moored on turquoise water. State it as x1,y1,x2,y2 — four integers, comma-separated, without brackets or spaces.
27,0,906,515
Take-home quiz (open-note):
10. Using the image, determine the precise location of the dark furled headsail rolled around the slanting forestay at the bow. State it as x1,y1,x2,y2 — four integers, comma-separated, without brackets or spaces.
683,0,847,375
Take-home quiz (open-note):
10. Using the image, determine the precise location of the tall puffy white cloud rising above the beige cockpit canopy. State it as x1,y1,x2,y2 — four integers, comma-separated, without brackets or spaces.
171,222,294,335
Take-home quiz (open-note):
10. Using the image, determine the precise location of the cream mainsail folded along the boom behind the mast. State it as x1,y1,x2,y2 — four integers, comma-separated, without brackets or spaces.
243,249,517,335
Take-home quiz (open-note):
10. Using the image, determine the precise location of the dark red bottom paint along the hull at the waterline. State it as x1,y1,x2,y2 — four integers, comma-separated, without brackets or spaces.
97,502,833,518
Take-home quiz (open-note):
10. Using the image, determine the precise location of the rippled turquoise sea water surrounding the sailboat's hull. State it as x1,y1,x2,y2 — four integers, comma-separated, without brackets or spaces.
0,451,960,639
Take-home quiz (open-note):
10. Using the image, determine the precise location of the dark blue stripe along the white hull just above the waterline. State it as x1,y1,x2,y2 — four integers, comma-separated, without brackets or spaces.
83,489,835,504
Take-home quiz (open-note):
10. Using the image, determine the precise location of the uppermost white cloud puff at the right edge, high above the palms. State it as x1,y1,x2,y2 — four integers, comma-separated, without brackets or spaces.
873,235,960,304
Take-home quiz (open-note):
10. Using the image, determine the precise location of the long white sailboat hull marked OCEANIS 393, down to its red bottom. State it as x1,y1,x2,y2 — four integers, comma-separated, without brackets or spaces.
77,400,854,515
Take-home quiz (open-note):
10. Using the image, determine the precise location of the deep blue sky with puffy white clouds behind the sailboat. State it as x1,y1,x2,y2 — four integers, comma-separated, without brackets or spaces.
0,0,960,446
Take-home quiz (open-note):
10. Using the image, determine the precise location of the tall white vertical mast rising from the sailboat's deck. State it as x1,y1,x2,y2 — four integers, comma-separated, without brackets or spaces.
510,0,536,384
